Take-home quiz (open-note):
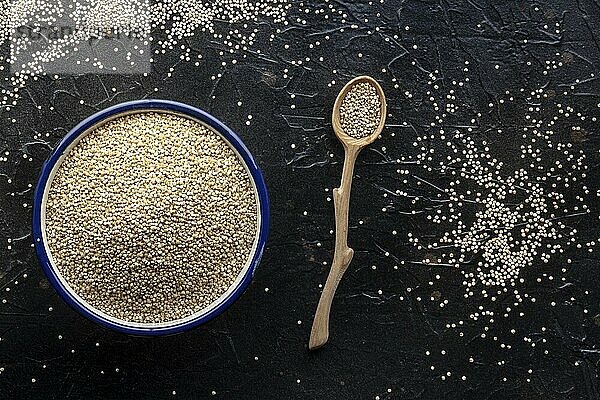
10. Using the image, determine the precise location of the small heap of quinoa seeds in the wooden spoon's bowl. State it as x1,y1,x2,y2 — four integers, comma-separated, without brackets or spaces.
340,82,381,139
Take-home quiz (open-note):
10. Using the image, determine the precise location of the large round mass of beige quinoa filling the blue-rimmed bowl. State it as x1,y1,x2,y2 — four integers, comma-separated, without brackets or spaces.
45,112,258,324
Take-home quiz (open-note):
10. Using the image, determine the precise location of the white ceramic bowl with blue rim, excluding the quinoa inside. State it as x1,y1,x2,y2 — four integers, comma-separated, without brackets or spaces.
33,100,269,335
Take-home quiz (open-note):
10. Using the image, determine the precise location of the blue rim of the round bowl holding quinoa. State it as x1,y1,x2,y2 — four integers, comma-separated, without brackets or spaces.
33,99,269,336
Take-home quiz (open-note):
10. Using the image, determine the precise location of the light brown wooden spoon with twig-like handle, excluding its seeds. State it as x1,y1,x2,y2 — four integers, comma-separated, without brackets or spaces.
308,76,387,350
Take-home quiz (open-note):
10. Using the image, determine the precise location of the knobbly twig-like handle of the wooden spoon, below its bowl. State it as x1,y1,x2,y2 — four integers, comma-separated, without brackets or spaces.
308,146,360,350
